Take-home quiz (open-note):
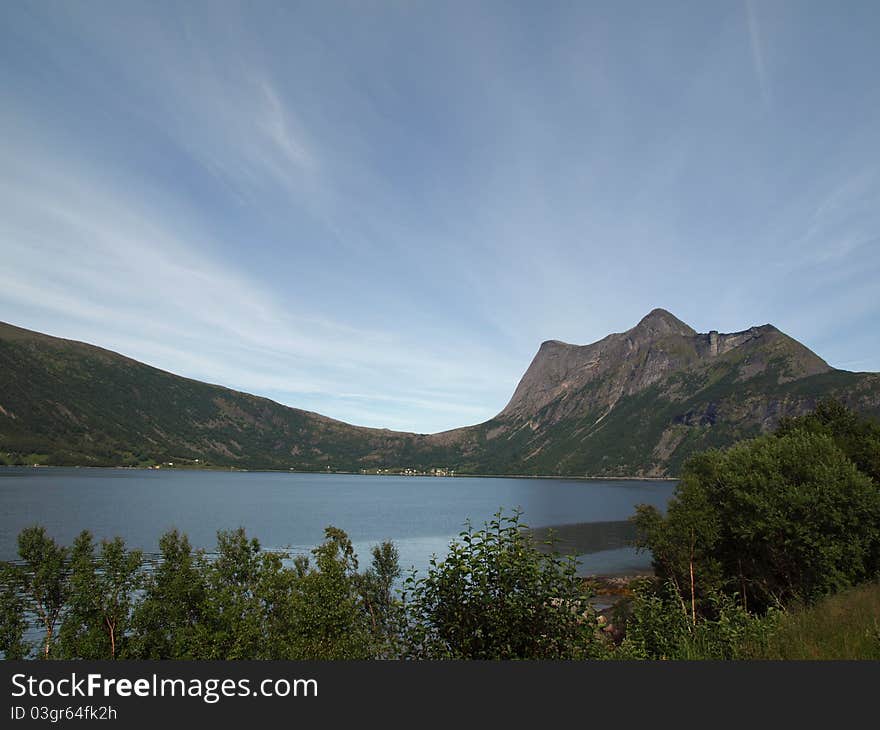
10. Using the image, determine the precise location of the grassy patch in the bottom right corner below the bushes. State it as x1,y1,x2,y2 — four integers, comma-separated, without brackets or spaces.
750,582,880,659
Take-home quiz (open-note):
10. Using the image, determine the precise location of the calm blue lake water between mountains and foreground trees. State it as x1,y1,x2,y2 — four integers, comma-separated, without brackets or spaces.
0,468,673,573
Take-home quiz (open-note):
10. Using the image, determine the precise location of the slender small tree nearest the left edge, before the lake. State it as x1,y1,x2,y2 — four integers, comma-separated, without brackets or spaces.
18,525,68,659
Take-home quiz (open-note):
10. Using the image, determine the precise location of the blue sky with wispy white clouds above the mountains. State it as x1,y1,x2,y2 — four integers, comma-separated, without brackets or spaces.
0,0,880,433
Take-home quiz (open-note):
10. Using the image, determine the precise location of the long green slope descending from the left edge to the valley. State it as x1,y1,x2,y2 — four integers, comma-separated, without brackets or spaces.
0,325,454,469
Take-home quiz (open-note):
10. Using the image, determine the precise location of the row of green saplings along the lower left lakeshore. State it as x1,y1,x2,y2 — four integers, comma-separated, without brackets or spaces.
0,527,401,660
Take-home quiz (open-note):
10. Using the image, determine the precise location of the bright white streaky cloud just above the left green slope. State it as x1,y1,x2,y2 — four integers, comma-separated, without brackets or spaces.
0,123,516,430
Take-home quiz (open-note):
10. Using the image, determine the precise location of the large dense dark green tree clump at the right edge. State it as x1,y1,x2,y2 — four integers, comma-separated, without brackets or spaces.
635,420,880,614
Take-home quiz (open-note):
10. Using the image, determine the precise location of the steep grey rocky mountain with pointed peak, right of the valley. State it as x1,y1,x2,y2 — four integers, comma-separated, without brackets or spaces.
432,309,880,476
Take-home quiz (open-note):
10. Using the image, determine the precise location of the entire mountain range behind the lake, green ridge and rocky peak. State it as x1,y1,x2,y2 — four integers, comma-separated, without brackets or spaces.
0,309,880,476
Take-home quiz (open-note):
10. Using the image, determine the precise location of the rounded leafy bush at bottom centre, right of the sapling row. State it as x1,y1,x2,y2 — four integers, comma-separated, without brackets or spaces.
405,512,599,659
